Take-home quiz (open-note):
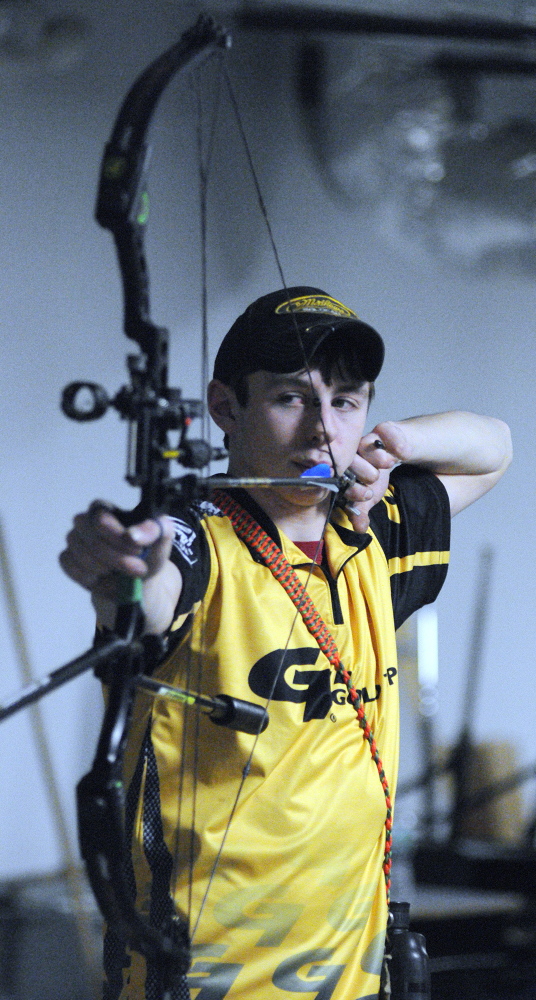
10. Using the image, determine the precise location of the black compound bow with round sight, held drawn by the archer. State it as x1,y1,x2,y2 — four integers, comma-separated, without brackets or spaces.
62,16,346,1000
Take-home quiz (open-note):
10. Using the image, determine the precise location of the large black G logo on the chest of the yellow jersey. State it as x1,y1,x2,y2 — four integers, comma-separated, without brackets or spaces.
248,647,332,722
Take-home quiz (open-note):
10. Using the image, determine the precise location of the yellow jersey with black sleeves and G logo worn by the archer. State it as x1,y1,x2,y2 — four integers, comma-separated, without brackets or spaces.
105,469,449,1000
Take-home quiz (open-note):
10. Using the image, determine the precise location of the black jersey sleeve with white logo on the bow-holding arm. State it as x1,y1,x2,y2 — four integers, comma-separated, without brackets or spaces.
169,507,210,618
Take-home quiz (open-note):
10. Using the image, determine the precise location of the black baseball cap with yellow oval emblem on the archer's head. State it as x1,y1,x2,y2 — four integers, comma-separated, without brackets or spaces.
214,285,385,385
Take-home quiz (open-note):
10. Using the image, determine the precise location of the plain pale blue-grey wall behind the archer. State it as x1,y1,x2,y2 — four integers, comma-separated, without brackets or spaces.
0,4,536,878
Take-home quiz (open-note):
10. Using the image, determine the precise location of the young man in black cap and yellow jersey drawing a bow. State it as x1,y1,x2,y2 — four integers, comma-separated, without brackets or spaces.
60,287,511,1000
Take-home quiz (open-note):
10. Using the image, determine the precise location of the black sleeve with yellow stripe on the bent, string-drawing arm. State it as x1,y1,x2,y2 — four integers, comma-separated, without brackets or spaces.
370,465,450,628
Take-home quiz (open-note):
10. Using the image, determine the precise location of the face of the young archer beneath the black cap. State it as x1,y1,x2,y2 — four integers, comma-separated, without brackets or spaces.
229,370,369,503
